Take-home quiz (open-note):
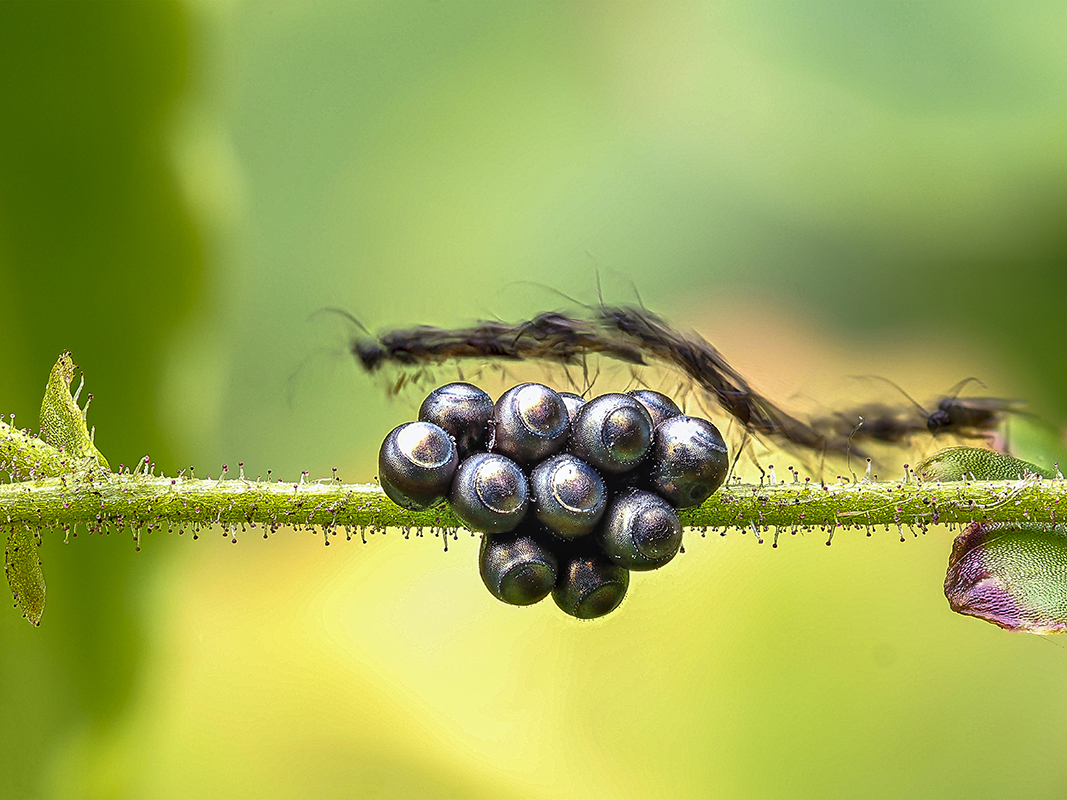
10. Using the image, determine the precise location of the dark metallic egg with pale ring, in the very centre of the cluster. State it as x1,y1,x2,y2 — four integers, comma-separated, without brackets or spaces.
530,453,607,539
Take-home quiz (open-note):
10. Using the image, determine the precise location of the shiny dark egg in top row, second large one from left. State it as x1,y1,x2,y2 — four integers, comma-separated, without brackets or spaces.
493,383,570,464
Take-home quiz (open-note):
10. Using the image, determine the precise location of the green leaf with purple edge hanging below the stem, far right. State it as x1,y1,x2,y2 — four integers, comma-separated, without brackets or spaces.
944,523,1067,634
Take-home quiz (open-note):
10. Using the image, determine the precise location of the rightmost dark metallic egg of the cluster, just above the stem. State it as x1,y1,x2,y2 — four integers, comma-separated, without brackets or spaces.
652,417,730,509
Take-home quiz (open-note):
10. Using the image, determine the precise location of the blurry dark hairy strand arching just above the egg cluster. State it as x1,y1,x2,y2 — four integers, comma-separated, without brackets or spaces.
334,304,1023,455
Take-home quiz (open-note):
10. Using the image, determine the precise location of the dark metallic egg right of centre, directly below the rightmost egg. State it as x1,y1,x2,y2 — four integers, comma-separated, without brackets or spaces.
596,490,682,570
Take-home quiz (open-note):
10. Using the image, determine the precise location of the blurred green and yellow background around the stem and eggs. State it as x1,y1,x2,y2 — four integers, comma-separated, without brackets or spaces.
0,0,1067,800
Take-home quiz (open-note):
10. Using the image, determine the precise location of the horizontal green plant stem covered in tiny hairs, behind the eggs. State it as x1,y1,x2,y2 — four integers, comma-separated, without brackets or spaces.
0,422,1067,533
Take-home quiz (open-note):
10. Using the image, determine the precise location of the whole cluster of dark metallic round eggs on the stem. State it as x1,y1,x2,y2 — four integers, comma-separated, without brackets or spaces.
378,383,729,619
